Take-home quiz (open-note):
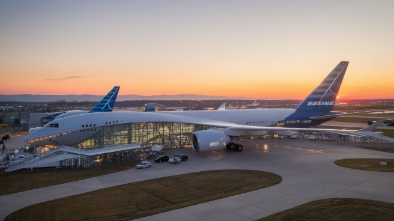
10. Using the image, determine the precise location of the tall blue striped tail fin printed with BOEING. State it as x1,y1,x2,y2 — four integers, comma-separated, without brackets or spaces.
286,61,349,120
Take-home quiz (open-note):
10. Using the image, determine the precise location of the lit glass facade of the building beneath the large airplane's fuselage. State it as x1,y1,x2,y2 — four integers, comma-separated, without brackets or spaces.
78,122,210,148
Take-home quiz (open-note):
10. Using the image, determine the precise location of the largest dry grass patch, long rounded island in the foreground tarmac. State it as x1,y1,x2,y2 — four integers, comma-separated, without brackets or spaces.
6,170,282,221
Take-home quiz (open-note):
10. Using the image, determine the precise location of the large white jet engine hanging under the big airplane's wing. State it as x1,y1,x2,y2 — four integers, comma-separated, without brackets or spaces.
192,130,230,152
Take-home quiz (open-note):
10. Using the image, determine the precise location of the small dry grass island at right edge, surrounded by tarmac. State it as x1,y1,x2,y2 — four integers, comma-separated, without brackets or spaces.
334,158,394,172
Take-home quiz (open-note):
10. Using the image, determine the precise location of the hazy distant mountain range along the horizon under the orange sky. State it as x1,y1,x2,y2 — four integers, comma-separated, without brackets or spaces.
0,94,252,102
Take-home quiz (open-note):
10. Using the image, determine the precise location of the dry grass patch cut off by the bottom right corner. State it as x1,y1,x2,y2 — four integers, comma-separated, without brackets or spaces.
259,198,394,221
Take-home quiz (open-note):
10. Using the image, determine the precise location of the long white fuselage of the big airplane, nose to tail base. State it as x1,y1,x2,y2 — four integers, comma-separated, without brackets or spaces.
24,109,294,145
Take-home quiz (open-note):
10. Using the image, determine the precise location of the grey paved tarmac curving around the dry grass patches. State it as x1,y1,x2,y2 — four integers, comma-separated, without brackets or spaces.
0,139,394,221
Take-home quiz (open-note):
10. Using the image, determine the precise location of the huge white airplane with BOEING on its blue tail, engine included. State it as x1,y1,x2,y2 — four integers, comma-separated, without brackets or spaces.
24,61,392,151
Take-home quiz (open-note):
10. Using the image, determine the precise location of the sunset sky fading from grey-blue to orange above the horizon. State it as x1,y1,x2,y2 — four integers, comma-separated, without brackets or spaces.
0,0,394,99
